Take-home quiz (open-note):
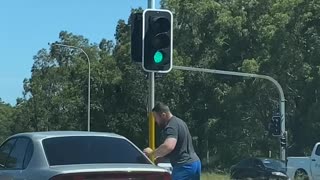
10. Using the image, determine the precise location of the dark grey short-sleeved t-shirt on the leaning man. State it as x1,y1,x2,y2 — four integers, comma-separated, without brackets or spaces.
163,116,199,166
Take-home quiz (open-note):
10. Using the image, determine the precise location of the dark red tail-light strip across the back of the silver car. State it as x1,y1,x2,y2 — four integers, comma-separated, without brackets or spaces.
50,172,171,180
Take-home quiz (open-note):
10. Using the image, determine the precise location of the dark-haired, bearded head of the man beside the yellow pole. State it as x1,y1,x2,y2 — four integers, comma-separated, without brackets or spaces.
152,102,172,128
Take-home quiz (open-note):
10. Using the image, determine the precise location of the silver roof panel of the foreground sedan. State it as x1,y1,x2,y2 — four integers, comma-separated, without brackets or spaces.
10,131,125,139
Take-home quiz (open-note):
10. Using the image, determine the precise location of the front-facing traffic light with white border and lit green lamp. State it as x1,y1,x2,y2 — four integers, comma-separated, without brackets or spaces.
142,9,173,73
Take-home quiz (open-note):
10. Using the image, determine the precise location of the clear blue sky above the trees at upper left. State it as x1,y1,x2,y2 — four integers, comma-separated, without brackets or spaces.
0,0,160,105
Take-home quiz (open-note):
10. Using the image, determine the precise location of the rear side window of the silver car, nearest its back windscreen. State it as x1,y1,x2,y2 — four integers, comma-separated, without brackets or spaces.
5,138,30,169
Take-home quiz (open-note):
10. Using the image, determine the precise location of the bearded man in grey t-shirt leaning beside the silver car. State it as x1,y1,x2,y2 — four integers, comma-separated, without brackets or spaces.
143,103,201,180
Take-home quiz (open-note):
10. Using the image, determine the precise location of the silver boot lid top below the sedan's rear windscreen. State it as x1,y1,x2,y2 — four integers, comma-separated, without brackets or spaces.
50,164,167,174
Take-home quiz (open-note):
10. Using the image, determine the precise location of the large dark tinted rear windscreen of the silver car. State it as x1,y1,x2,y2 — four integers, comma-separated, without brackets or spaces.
42,136,150,166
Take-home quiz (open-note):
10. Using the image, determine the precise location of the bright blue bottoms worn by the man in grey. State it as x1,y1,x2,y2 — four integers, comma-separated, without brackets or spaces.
171,160,201,180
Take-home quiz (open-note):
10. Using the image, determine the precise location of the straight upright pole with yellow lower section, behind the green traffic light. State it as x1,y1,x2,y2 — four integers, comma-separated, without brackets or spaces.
148,0,155,150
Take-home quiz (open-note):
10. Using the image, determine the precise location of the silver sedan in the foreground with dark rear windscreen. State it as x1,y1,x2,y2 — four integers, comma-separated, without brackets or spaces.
0,131,171,180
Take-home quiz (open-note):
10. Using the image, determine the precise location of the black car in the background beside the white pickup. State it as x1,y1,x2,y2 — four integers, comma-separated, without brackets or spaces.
230,157,289,180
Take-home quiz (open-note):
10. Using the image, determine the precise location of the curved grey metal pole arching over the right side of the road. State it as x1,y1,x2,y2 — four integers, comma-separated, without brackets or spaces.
173,66,286,160
